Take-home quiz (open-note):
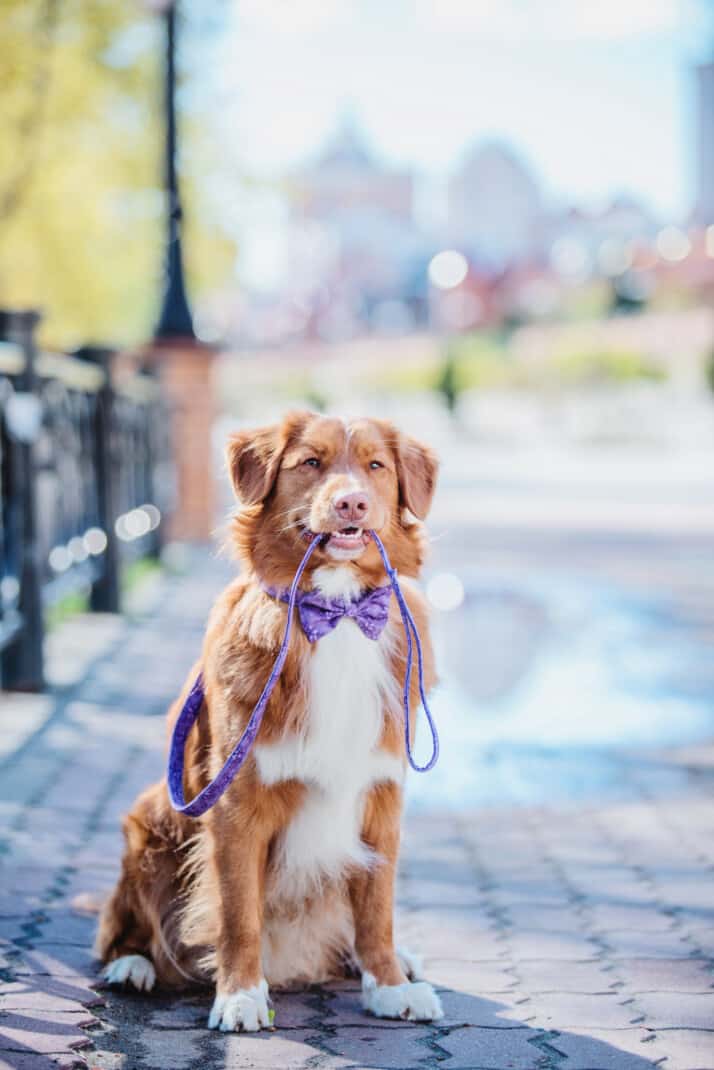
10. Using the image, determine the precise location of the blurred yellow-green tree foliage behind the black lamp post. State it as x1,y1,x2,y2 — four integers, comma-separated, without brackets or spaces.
0,0,234,347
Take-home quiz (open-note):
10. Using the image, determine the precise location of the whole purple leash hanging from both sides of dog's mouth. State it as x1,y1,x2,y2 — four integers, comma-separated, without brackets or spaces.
167,531,439,817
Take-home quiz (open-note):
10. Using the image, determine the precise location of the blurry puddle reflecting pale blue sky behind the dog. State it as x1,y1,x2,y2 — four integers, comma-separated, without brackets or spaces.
408,575,714,808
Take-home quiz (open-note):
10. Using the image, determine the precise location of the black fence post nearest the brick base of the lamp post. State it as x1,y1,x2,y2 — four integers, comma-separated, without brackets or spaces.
77,346,121,613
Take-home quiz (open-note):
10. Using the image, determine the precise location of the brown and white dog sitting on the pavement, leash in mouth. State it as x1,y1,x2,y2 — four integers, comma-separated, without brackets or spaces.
96,413,441,1030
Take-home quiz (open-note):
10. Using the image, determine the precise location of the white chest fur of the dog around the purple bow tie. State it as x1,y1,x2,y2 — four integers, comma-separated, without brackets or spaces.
255,567,404,898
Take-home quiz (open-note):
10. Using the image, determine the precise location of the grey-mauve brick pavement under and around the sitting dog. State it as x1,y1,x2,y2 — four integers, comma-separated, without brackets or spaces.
0,559,714,1070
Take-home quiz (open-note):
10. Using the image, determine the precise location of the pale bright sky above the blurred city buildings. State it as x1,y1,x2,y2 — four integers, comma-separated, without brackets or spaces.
203,0,714,219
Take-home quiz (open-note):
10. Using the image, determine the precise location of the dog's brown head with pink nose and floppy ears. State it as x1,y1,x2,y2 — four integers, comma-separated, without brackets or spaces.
228,412,438,583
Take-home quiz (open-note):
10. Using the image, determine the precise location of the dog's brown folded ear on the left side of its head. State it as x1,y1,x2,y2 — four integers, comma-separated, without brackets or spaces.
226,412,309,505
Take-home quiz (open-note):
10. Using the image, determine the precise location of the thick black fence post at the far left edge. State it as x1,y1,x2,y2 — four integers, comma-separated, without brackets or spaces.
0,310,45,691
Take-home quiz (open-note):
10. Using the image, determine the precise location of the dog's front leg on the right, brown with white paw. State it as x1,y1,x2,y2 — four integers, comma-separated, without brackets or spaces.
350,782,443,1022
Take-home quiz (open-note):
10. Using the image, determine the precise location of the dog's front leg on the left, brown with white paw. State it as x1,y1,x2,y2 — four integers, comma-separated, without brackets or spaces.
209,805,272,1033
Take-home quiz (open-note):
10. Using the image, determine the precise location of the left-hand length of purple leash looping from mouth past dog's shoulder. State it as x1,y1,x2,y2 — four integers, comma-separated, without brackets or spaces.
166,534,324,817
